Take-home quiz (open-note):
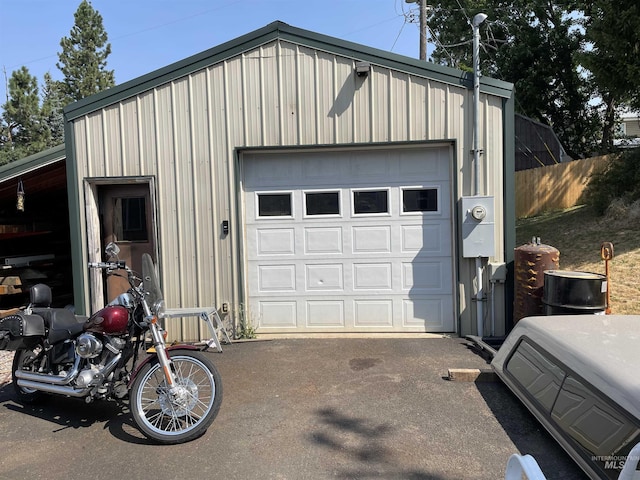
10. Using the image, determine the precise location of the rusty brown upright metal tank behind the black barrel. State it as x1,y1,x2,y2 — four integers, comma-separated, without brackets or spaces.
513,238,560,324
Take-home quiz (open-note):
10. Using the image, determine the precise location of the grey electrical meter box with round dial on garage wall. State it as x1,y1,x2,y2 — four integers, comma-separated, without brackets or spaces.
461,196,495,258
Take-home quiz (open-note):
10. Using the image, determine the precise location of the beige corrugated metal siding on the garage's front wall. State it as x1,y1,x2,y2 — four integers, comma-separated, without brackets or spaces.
74,36,503,339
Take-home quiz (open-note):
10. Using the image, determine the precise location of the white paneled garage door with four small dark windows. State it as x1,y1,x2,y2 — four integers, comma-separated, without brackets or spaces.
242,146,455,333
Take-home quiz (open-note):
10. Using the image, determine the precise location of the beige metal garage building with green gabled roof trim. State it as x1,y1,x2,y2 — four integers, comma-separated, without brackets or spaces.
65,22,515,340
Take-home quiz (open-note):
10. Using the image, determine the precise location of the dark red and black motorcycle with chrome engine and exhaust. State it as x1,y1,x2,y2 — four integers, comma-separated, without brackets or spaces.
0,243,222,444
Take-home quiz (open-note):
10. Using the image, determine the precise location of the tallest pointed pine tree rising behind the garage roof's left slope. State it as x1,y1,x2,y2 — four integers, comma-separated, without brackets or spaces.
56,0,115,102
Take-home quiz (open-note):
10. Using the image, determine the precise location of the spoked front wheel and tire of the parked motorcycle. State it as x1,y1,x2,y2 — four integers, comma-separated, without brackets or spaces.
129,351,222,444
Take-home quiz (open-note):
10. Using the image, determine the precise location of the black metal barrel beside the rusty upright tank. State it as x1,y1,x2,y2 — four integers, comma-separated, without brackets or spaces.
542,270,607,315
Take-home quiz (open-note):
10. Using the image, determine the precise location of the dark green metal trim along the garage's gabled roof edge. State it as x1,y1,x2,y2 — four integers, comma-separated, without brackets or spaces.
64,21,513,121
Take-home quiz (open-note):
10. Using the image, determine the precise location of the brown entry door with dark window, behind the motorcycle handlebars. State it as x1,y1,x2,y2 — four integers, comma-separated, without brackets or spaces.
99,183,156,301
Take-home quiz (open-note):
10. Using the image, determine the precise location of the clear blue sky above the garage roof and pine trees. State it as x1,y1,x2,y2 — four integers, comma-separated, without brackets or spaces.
0,0,430,104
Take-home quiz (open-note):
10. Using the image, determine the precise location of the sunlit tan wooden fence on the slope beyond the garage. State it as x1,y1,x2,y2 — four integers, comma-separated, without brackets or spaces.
515,156,608,218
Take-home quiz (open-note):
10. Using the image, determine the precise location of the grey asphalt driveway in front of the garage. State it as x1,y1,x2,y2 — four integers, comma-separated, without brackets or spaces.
0,338,584,480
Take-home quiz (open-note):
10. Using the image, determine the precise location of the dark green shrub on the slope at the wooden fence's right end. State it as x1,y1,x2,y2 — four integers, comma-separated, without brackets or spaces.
585,148,640,215
